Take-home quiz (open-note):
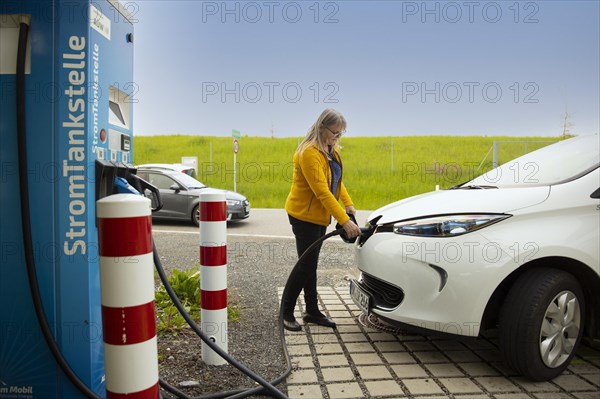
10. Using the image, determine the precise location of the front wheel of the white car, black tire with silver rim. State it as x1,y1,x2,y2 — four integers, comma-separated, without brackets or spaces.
498,268,585,381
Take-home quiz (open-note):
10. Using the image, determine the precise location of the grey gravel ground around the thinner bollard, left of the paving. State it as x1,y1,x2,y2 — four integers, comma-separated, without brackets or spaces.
154,233,357,397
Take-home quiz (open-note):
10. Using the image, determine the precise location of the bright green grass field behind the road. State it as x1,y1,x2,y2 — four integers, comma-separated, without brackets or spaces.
134,135,558,209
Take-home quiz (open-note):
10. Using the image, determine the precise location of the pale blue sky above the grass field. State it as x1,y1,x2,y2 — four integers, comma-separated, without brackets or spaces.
131,0,600,137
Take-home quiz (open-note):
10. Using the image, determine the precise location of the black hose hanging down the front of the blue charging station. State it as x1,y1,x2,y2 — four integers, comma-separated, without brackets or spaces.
16,22,100,399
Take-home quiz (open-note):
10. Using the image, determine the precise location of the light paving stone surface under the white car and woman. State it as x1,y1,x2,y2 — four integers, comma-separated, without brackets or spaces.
278,287,600,399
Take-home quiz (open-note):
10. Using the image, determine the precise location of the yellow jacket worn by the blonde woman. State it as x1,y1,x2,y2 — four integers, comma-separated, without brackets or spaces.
285,146,352,226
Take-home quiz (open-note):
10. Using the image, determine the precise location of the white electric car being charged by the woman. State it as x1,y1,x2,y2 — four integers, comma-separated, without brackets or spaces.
350,135,600,381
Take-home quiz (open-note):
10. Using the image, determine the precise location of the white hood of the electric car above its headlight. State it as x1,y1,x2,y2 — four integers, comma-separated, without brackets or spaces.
369,186,550,224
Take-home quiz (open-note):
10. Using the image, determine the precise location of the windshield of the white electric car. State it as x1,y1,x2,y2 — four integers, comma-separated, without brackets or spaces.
462,135,600,188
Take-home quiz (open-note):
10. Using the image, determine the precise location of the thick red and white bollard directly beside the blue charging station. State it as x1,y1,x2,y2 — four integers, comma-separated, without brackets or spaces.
96,194,160,399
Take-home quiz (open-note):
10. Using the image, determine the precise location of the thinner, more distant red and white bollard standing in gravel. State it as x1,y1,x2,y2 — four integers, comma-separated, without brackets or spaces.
199,191,227,365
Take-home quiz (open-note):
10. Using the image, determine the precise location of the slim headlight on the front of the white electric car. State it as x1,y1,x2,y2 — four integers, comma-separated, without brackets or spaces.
392,214,511,237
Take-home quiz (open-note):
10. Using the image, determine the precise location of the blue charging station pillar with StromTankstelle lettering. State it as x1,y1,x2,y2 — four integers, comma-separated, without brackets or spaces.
0,0,136,399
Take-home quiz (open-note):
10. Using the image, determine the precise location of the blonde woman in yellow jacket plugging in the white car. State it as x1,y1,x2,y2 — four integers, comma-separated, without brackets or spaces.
282,109,360,331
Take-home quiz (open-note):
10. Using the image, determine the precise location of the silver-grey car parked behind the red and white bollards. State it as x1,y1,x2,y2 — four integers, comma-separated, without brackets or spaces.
137,168,250,226
